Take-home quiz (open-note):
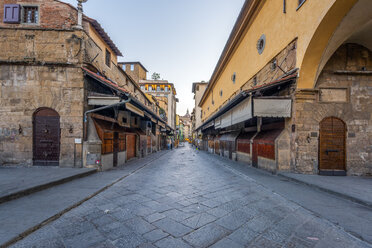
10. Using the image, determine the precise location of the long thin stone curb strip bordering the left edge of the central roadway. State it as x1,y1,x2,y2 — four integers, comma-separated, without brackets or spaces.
0,151,169,248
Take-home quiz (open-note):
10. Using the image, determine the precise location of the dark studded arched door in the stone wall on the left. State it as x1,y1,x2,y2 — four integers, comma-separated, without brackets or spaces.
33,108,61,166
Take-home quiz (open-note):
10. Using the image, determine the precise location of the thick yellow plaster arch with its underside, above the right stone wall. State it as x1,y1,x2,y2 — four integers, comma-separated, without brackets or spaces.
298,0,372,89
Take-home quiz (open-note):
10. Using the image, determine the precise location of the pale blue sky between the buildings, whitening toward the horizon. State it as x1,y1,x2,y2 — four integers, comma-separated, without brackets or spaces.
63,0,244,115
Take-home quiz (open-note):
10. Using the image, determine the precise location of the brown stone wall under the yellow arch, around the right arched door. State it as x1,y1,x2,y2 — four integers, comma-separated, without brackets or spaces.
292,44,372,175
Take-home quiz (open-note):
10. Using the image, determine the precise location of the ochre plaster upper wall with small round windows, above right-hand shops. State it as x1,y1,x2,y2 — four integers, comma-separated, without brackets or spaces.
202,0,356,121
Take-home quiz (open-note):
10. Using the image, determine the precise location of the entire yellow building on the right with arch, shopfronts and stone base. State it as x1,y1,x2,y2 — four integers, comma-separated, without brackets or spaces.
199,0,372,175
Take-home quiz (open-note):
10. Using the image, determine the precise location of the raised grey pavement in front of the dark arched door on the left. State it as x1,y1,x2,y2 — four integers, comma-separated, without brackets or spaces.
0,167,96,203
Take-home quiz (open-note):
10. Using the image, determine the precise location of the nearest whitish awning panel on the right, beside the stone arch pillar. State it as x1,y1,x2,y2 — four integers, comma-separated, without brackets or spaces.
253,98,292,117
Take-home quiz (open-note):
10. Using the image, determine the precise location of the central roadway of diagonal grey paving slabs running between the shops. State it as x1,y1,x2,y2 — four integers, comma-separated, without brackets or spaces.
13,146,371,248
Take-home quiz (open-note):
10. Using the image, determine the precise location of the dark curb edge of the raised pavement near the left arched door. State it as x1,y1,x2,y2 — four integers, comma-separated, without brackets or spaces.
0,169,97,204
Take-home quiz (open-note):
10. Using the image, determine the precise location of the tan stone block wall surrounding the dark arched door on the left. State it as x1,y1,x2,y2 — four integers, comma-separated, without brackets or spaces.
0,65,84,167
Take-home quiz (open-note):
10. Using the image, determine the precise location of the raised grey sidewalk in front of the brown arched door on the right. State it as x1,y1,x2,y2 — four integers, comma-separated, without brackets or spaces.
278,172,372,207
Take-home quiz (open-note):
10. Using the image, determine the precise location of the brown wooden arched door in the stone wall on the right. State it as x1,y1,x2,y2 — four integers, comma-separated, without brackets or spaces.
319,117,346,176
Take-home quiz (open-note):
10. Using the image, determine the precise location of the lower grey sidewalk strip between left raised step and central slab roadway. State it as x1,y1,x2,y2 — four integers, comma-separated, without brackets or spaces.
0,151,168,247
